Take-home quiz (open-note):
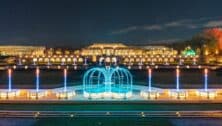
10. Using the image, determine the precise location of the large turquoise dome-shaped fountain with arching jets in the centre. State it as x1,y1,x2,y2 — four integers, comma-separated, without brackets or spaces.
83,67,132,98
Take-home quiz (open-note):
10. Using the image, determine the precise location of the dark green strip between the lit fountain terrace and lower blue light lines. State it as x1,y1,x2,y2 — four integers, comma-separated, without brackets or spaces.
0,101,222,112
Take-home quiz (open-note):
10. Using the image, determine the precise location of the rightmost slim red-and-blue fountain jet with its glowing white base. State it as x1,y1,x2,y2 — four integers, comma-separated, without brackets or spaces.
197,68,217,99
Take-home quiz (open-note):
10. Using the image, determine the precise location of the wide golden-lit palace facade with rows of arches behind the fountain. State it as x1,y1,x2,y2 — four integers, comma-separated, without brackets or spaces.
10,43,198,66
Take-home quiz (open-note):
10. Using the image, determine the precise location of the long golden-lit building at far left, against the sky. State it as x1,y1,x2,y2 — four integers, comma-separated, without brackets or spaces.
0,46,45,56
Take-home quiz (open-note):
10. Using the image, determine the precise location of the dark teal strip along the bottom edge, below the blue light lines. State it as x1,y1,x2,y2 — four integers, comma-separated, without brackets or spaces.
3,118,222,126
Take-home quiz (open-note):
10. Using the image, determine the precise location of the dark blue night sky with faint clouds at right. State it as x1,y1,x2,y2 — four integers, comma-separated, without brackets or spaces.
0,0,222,47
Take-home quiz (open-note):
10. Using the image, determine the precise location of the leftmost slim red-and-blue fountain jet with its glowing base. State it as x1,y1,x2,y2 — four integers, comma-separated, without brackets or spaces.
0,69,18,99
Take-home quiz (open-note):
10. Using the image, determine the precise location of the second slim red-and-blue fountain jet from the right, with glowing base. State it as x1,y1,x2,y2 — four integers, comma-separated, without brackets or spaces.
169,68,187,99
